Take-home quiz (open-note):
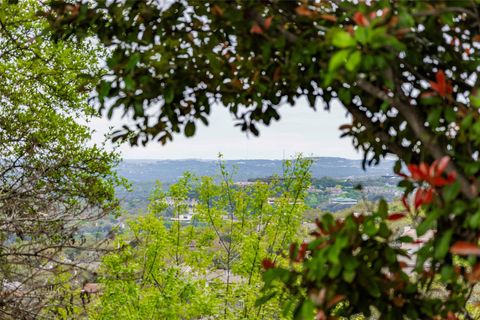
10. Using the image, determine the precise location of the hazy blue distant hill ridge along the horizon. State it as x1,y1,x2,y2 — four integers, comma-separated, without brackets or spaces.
118,157,393,184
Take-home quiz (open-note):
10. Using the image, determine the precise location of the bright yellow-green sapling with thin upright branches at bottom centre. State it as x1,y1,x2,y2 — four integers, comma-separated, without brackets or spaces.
90,158,311,319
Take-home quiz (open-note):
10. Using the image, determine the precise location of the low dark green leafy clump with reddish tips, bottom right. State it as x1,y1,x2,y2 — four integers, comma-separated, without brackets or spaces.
261,202,468,319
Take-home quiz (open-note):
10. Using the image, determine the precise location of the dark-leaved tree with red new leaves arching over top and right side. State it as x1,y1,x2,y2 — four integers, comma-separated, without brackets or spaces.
44,0,480,319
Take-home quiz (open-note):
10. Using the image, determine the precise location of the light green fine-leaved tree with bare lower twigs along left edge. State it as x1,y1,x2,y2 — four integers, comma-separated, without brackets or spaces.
0,0,124,319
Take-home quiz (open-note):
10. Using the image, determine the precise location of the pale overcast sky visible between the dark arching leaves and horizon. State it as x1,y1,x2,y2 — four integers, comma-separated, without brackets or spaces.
90,99,360,159
